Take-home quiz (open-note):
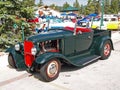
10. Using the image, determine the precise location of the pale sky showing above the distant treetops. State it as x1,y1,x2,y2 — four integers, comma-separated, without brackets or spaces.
36,0,88,6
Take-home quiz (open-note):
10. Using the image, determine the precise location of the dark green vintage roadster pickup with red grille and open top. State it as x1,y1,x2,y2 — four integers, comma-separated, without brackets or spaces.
8,27,113,82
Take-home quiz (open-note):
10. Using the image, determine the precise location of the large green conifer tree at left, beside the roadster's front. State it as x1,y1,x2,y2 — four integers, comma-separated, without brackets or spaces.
0,0,34,50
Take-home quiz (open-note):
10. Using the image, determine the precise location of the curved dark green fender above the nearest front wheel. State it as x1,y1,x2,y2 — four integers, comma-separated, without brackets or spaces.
35,52,67,64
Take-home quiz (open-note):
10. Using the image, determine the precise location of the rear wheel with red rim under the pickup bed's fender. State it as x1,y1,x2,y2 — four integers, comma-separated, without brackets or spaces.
101,41,112,60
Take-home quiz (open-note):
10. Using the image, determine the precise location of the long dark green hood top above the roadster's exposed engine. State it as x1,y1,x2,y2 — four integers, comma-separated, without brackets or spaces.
26,30,73,43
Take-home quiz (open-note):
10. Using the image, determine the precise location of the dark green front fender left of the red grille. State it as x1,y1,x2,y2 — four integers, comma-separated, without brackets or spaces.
6,47,26,69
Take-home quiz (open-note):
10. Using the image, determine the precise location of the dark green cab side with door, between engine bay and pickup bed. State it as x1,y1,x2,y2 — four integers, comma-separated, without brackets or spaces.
62,31,93,55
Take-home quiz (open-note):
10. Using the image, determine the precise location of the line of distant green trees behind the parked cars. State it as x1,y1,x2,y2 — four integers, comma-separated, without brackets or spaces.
50,0,120,15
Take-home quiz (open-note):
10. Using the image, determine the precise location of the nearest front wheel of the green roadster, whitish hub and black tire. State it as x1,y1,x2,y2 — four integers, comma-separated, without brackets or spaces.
40,59,61,82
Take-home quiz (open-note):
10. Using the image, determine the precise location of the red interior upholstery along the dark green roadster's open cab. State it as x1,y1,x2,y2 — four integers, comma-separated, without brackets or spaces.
65,26,91,33
